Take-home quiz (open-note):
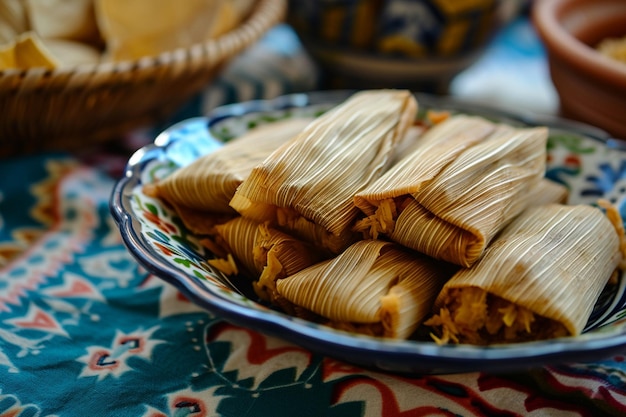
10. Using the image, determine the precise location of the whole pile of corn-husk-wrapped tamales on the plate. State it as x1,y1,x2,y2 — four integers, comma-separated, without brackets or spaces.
149,90,626,344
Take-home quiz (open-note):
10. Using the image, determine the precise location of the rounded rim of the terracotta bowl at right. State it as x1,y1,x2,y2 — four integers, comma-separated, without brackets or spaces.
532,0,626,89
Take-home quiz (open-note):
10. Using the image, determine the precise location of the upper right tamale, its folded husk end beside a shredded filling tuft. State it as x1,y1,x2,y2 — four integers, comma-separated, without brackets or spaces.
355,116,547,267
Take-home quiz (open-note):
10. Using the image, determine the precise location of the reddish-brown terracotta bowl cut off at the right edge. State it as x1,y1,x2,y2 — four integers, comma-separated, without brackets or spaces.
532,0,626,139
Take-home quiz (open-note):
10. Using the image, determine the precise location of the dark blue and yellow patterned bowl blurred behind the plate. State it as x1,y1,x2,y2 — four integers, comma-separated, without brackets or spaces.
288,0,520,92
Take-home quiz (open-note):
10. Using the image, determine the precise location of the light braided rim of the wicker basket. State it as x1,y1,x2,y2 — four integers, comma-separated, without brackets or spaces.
0,0,287,80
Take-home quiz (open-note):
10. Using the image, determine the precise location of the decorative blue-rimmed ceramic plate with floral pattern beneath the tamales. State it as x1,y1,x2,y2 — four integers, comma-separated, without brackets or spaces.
111,91,626,374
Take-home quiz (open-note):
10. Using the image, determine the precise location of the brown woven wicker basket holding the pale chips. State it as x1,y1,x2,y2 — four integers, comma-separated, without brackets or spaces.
0,0,287,157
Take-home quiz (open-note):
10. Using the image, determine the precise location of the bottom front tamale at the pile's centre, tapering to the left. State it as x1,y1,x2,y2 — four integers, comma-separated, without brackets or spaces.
276,240,453,339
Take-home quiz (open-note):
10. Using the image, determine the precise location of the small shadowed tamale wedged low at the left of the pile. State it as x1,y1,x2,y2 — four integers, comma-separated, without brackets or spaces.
216,217,321,301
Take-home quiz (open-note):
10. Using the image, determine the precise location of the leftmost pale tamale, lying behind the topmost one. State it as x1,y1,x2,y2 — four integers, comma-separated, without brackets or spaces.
156,118,313,214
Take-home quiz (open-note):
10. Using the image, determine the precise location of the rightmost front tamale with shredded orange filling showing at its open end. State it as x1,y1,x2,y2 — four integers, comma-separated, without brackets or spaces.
425,204,623,344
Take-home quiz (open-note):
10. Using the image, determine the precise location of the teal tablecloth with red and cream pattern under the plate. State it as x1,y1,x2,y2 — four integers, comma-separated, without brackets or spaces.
0,17,626,417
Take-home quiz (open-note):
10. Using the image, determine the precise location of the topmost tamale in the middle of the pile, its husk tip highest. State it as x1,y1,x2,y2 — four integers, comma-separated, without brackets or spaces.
230,90,417,254
